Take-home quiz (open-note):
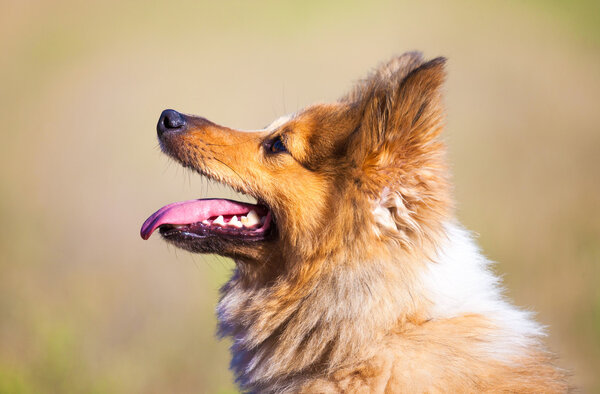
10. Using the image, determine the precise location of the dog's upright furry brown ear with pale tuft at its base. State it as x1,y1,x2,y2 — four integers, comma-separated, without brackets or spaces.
347,53,451,245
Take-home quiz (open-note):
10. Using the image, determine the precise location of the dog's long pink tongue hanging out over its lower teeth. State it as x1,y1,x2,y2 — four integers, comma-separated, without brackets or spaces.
140,199,256,239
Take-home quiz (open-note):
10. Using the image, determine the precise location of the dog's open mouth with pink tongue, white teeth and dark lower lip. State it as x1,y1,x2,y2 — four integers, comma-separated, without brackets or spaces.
140,199,274,241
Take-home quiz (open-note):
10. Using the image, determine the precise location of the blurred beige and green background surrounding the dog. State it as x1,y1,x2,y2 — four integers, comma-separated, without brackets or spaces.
0,0,600,393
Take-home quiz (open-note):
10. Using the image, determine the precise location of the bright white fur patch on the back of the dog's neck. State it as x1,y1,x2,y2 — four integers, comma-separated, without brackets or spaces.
422,223,544,361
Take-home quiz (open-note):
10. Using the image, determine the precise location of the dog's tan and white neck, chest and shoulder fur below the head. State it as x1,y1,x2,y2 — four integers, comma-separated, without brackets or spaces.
218,223,566,392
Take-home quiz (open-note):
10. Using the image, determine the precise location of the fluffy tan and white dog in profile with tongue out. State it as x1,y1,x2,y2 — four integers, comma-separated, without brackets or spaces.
141,52,569,393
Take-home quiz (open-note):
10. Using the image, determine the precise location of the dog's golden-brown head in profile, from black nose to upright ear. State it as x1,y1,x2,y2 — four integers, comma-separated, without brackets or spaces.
142,53,450,274
